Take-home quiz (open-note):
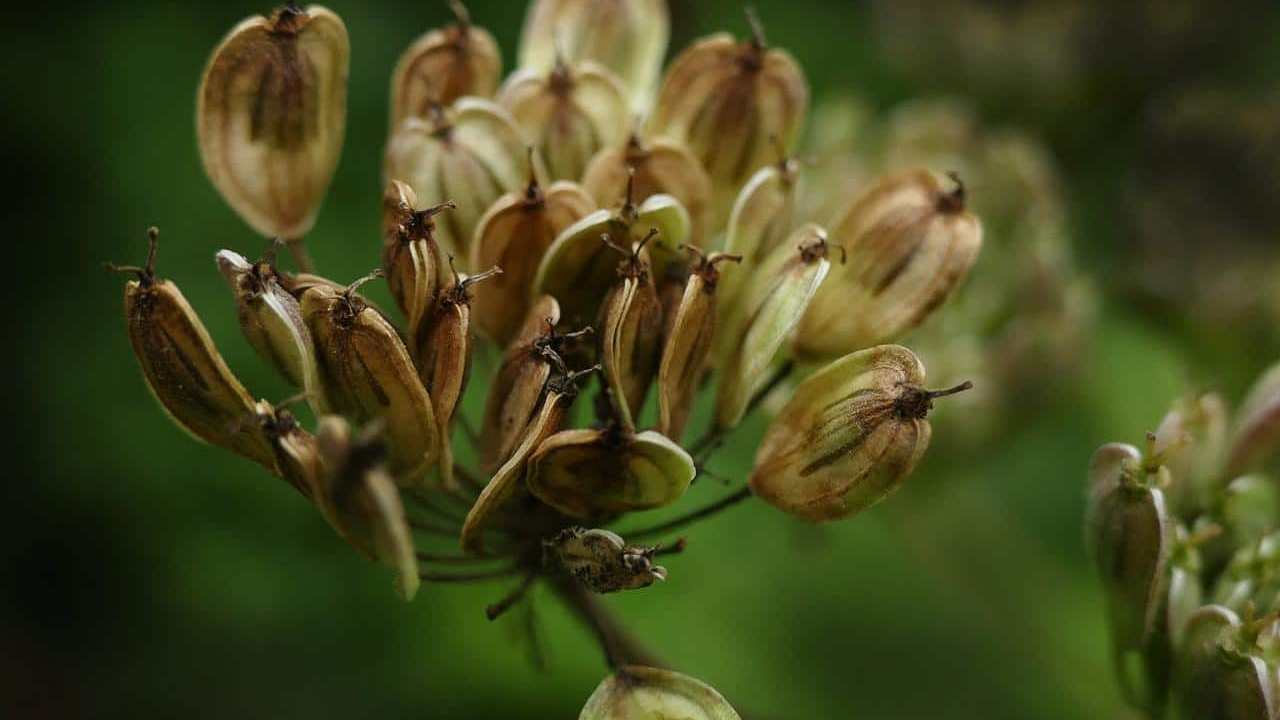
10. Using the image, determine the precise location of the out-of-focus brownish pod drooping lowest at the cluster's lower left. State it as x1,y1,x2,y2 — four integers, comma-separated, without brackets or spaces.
316,415,420,601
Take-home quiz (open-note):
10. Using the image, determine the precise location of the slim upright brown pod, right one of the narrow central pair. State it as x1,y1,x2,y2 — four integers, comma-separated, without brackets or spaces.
658,246,741,443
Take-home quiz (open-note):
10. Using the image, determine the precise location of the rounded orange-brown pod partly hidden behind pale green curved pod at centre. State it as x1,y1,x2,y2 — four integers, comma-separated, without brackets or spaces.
582,132,712,247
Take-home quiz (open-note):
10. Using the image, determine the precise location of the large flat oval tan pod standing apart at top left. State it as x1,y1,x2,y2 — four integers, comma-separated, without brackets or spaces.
196,3,351,240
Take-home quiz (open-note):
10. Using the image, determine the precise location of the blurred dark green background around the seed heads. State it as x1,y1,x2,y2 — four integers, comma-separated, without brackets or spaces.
10,0,1280,720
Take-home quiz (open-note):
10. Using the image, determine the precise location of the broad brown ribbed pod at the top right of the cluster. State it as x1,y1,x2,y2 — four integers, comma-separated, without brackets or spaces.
649,17,809,220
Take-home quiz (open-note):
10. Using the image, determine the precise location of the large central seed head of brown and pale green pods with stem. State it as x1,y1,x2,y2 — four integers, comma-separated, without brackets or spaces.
104,0,993,719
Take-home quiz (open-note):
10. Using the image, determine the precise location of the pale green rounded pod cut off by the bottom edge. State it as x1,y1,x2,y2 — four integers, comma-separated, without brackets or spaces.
577,665,741,720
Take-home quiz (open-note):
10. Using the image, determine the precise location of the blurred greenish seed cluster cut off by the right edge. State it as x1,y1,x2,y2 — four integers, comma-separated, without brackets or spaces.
1085,365,1280,720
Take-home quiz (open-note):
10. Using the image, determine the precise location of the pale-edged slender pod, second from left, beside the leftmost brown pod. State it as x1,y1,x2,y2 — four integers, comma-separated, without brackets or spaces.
215,250,316,391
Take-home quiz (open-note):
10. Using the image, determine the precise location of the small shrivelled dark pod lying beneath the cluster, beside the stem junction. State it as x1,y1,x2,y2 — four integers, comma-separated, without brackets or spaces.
545,527,667,594
